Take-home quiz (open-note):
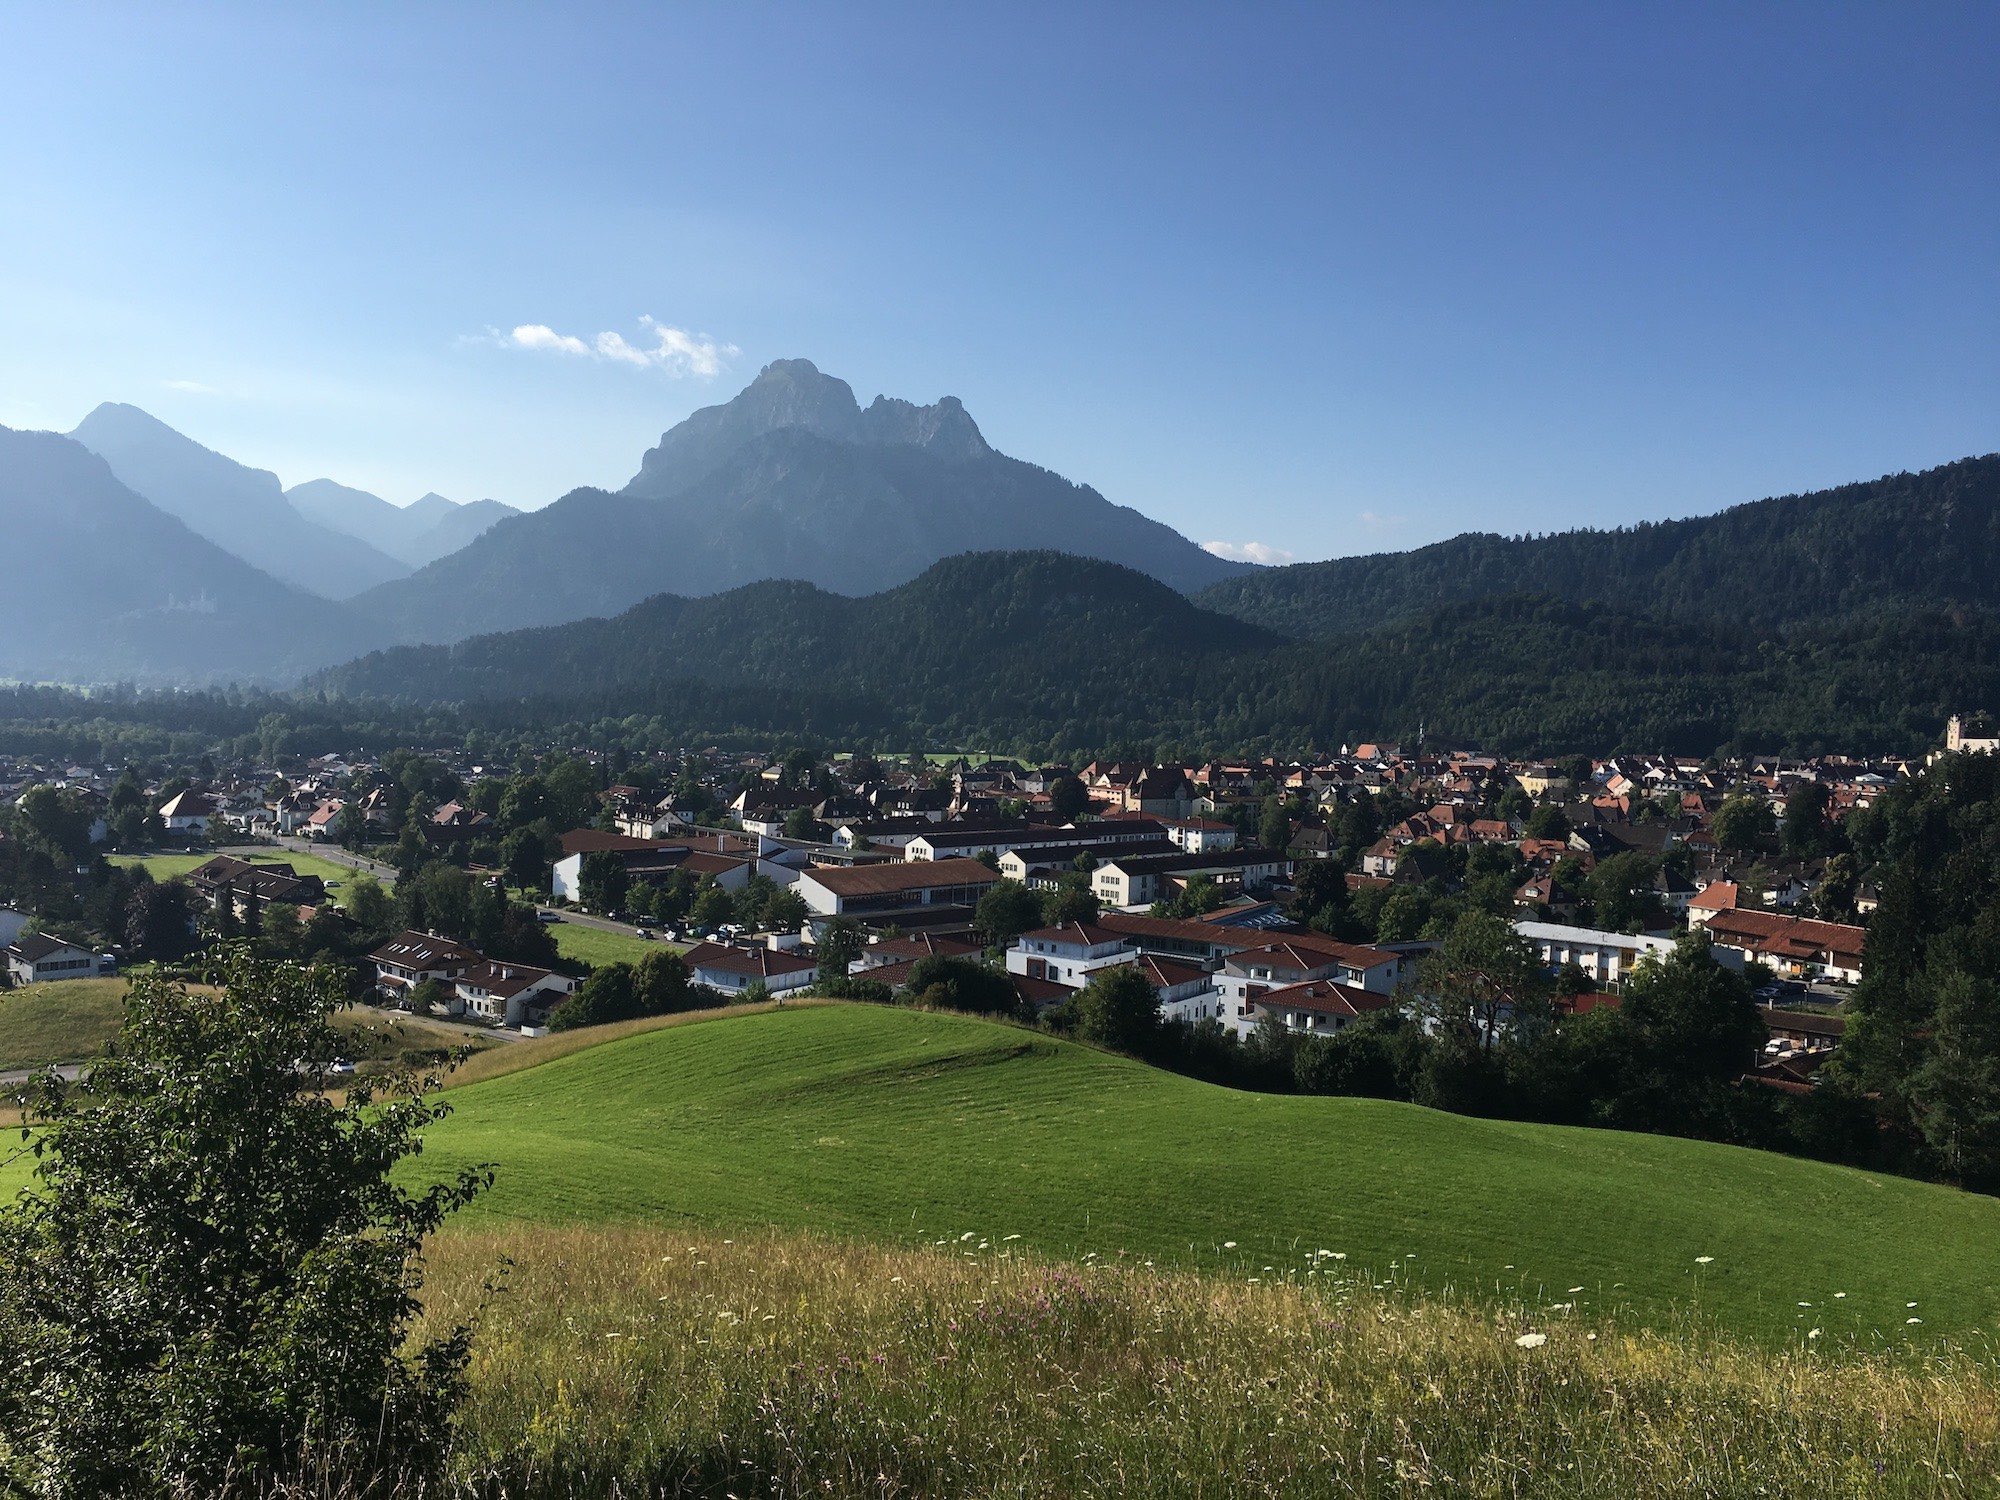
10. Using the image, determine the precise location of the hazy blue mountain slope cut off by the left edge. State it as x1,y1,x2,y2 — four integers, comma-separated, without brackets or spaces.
0,428,380,682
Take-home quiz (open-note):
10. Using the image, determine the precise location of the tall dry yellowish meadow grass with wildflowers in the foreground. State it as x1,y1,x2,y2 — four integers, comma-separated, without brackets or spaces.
398,1228,2000,1500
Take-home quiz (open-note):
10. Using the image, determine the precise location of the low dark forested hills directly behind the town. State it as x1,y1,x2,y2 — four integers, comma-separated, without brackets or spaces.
316,552,2000,756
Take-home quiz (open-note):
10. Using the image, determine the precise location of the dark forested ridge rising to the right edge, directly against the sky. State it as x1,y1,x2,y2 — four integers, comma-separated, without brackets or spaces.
1198,454,2000,638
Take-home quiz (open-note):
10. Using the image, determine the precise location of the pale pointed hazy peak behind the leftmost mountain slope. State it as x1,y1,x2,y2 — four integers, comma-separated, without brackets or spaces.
70,412,410,598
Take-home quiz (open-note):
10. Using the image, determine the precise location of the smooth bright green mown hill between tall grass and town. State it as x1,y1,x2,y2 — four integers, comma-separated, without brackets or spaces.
424,1006,2000,1346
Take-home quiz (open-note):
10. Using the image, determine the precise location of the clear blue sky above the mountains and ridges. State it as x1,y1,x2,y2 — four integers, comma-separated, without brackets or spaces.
0,0,2000,558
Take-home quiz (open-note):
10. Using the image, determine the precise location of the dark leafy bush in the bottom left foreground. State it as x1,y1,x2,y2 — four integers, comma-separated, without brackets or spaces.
0,948,486,1496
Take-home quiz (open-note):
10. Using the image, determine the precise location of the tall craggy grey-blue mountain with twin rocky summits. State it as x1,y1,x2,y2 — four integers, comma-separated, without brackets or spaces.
352,360,1246,640
